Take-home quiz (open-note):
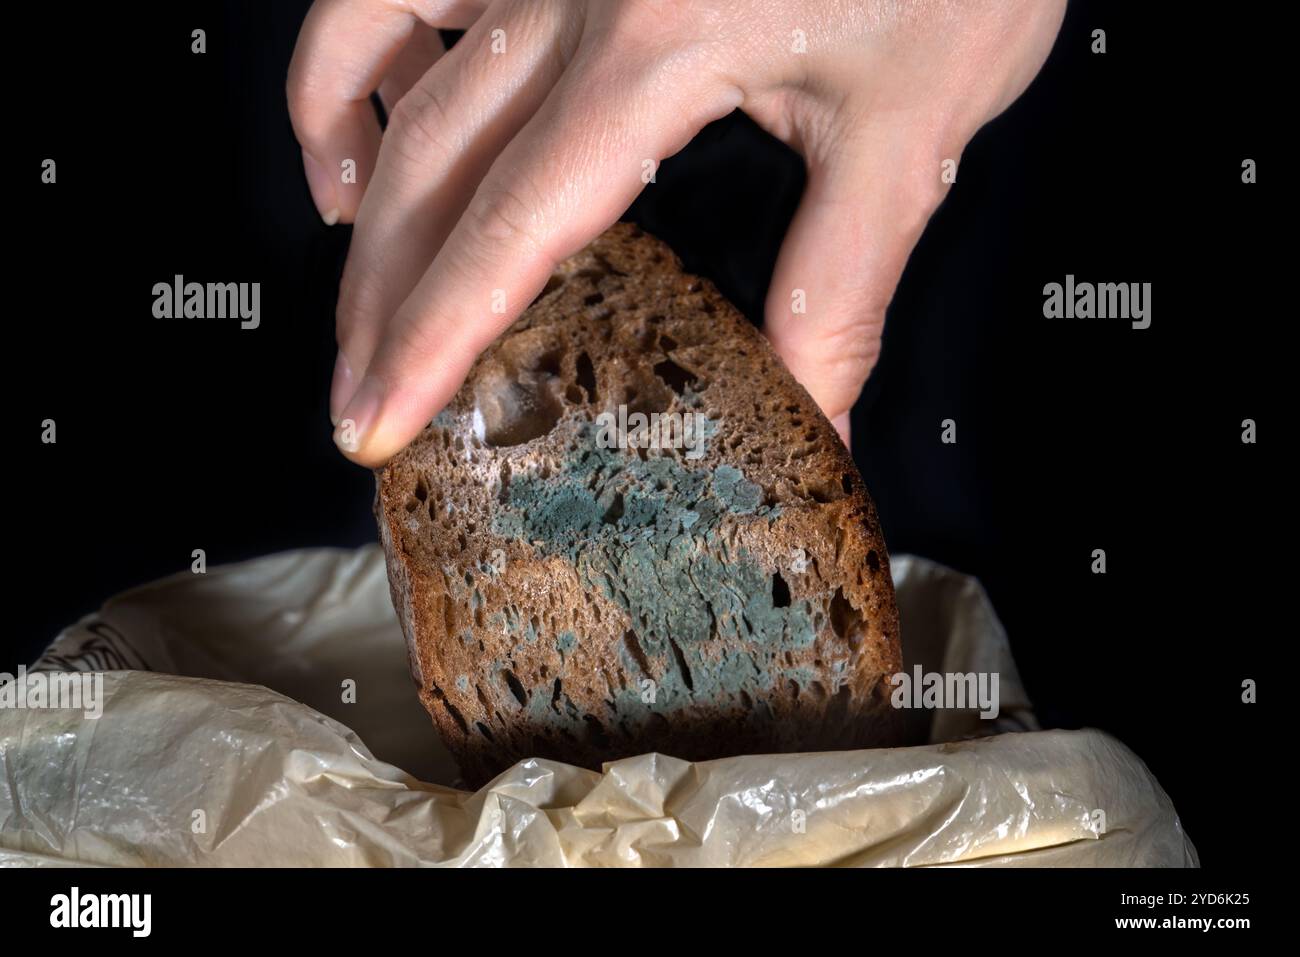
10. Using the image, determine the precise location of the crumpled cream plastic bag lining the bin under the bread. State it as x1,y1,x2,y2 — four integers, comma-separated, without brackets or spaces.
0,546,1197,866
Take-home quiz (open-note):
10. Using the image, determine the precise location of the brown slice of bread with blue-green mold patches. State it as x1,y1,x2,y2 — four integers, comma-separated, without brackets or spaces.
376,224,901,787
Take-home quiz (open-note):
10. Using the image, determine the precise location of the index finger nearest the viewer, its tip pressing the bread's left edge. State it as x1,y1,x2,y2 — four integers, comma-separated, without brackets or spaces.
335,57,740,465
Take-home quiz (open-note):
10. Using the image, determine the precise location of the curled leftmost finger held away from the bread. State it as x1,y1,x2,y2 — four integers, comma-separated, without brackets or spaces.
287,0,478,225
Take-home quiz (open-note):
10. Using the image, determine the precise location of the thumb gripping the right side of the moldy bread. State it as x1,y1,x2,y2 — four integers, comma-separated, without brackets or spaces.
764,127,944,445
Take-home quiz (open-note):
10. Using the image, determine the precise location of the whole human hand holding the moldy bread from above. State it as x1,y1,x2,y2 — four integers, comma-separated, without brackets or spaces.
289,0,1065,465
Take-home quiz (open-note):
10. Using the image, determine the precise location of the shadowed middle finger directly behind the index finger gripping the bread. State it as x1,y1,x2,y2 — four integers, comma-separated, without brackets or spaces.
330,0,581,423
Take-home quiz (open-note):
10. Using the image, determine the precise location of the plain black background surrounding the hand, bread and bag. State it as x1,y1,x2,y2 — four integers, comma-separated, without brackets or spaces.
15,0,1295,866
